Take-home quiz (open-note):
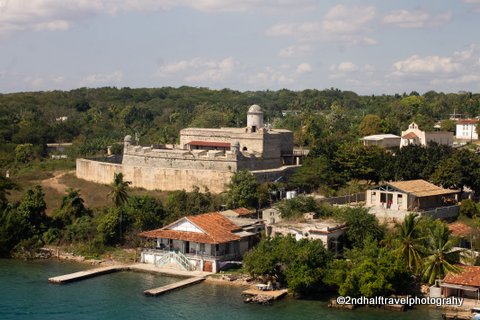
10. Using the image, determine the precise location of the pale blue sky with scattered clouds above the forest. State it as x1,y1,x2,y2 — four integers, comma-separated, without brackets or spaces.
0,0,480,95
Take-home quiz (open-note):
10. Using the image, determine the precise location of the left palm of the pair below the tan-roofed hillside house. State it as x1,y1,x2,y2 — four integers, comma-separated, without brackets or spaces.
395,213,425,274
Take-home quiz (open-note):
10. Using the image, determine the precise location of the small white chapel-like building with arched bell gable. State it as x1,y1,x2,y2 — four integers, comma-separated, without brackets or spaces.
400,122,453,148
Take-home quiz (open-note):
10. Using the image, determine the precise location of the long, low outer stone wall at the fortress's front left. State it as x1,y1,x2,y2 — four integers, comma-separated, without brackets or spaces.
76,159,233,193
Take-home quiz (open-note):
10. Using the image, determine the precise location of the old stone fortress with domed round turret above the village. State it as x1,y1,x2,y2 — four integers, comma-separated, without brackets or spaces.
76,105,304,193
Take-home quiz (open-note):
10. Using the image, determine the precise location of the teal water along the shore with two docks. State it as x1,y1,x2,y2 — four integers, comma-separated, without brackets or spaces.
0,260,441,320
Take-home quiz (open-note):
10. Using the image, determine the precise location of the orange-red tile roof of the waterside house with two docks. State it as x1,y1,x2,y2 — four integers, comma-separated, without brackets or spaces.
140,212,240,244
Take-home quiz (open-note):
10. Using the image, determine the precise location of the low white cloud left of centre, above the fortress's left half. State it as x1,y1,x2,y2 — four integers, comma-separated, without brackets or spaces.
159,57,236,82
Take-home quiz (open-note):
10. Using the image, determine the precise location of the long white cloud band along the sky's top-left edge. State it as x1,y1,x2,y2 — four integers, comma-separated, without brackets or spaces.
0,0,316,34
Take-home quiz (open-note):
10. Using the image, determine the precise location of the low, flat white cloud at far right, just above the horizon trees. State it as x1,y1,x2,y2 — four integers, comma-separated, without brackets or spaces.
393,55,460,74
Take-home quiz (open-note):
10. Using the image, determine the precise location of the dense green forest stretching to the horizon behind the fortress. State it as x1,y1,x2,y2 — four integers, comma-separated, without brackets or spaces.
0,87,480,170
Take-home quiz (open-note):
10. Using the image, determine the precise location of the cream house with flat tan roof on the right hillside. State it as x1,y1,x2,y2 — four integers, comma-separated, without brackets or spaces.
365,180,460,221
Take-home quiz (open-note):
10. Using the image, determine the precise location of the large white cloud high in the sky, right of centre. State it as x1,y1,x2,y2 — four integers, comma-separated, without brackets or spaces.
266,5,377,45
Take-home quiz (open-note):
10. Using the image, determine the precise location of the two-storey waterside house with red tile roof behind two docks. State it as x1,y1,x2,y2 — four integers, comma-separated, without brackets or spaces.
140,212,264,272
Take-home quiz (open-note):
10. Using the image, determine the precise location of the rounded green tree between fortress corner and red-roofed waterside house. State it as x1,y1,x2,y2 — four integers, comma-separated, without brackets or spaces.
227,170,258,208
